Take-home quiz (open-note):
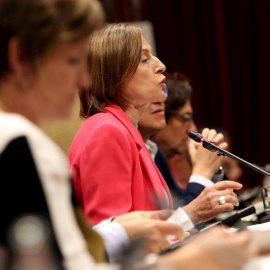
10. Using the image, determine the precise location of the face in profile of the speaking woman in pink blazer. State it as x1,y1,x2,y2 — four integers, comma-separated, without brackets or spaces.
124,37,166,110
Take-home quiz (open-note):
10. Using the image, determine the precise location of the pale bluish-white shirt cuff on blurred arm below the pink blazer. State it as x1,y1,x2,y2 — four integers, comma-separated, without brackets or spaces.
93,218,130,262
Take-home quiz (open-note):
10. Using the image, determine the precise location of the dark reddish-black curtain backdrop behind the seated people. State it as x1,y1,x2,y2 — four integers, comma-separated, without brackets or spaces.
101,0,270,187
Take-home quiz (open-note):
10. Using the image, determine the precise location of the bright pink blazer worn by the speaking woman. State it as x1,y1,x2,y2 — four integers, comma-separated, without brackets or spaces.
69,105,172,223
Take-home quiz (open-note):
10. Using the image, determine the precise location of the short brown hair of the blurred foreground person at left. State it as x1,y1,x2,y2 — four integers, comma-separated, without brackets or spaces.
0,0,105,78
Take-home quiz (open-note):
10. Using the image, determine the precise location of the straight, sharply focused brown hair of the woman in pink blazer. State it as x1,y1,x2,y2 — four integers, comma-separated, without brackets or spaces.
80,23,142,117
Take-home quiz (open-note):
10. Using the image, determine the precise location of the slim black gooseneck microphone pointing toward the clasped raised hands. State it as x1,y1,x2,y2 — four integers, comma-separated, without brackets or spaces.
188,131,270,176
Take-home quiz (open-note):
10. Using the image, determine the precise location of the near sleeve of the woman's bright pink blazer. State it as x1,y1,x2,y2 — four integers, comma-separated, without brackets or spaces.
80,125,134,223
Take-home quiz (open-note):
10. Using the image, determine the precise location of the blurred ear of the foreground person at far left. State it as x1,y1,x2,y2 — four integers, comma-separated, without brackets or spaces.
7,37,30,75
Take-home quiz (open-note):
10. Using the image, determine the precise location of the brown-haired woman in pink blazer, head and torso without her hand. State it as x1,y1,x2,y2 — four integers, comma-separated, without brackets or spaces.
69,24,172,223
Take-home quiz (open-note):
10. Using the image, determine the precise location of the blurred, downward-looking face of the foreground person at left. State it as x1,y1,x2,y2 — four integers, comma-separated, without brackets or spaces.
29,39,90,120
